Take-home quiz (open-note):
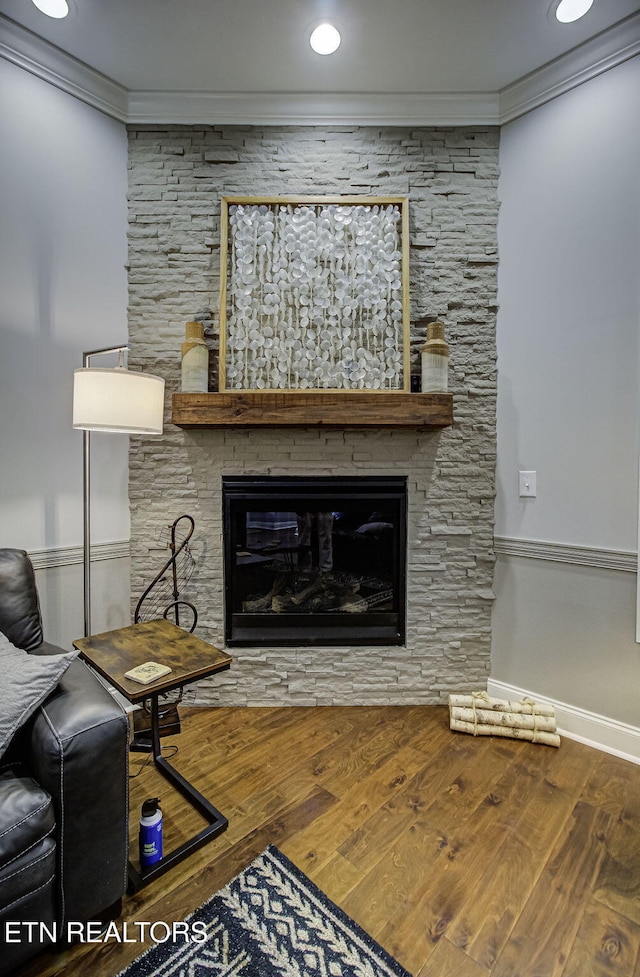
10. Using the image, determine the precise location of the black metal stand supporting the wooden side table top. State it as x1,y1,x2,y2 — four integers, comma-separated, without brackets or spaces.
129,695,229,892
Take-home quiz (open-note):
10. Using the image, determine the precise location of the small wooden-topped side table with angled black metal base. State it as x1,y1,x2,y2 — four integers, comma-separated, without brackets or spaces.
73,618,231,892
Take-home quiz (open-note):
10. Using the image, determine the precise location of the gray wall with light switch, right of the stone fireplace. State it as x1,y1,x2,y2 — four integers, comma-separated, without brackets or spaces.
492,58,640,726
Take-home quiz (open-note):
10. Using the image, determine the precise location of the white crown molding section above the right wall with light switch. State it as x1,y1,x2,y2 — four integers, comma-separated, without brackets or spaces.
500,13,640,125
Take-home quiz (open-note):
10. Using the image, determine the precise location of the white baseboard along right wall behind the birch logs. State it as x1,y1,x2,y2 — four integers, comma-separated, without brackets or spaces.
487,679,640,763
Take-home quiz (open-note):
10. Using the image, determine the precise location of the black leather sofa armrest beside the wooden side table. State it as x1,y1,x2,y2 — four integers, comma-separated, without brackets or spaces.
25,660,129,925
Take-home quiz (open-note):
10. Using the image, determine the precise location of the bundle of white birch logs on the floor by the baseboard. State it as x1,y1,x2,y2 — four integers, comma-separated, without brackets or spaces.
449,692,560,746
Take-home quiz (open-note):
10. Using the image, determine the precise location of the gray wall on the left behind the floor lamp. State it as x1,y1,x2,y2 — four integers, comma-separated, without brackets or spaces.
0,60,129,647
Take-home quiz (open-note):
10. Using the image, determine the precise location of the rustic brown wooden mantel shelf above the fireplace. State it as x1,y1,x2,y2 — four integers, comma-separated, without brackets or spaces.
171,390,453,429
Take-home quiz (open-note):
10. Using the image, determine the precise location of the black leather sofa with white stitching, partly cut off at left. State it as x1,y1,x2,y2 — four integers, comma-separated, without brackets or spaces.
0,549,129,975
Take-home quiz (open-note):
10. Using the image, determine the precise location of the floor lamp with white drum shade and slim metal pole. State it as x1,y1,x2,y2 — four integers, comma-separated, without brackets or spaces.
73,346,164,637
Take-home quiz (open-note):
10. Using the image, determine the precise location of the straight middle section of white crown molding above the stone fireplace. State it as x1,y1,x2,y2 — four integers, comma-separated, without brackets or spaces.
124,91,499,126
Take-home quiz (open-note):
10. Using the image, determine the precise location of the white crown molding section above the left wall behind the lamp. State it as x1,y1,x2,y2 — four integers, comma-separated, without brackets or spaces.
0,14,127,122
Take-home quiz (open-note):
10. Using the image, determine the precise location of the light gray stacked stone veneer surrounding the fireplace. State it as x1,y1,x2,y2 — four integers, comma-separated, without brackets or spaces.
129,126,499,705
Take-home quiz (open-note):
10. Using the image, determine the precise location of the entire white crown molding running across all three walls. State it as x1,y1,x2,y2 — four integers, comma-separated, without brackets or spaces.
0,13,640,126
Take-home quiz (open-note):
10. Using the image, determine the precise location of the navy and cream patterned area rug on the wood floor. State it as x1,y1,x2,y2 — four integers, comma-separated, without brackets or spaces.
118,846,411,977
